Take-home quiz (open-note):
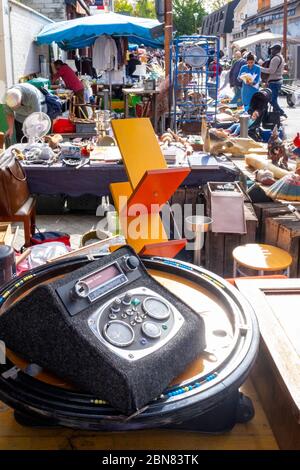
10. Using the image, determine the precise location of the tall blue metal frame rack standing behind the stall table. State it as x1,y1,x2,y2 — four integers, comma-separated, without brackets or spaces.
171,35,220,130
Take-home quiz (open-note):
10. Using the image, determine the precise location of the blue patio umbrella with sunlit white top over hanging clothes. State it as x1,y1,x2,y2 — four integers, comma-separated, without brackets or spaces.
36,12,163,50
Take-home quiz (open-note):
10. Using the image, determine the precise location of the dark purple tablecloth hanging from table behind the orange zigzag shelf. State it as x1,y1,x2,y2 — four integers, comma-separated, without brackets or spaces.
24,164,237,196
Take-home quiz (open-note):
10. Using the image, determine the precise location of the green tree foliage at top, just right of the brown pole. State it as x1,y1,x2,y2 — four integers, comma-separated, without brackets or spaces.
173,0,206,36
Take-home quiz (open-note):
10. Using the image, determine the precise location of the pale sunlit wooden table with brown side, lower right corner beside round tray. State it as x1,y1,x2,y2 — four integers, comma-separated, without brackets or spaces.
236,279,300,450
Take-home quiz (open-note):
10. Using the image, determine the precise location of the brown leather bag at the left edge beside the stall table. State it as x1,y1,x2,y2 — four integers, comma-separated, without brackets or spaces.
0,152,30,216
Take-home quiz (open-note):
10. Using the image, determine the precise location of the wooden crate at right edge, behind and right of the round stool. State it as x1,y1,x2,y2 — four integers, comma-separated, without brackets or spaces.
265,214,300,277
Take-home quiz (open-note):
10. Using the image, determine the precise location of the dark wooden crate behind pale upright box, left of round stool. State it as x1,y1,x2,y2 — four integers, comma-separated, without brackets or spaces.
205,203,258,277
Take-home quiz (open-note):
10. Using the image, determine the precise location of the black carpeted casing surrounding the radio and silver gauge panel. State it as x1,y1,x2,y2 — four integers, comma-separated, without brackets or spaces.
0,247,205,414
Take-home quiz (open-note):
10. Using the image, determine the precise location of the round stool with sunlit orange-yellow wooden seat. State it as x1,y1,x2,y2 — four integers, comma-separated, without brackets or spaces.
232,243,293,277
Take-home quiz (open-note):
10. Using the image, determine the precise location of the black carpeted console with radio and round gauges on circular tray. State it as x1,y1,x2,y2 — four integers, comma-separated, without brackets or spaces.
0,246,206,415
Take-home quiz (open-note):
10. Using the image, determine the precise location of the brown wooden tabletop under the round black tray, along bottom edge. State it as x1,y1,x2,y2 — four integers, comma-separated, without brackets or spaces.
0,380,278,450
